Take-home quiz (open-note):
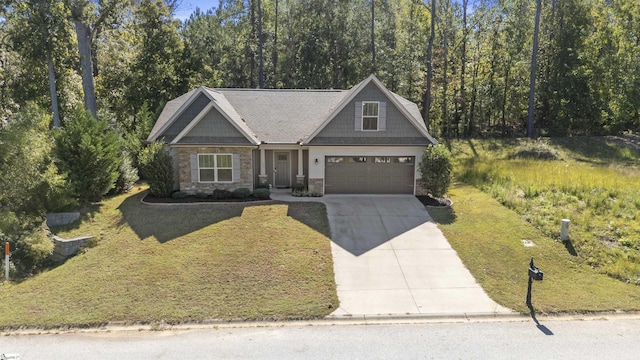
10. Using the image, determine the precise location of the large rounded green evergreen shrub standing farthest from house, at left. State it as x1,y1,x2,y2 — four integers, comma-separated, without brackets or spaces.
55,109,122,202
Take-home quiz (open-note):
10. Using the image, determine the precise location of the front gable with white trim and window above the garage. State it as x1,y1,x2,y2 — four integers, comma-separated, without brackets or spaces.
306,77,433,145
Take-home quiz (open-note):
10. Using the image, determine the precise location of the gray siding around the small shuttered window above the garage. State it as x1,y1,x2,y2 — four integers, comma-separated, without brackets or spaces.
309,83,430,145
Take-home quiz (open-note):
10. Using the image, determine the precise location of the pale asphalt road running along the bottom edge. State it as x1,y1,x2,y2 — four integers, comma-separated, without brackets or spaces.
0,319,640,360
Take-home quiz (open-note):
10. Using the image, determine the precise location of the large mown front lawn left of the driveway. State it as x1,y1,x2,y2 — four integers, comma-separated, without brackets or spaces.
0,190,338,328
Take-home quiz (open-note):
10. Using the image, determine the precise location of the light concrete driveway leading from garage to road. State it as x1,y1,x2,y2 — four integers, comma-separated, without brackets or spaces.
323,195,512,317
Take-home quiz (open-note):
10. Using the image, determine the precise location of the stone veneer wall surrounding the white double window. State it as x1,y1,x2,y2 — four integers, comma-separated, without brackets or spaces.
178,146,253,193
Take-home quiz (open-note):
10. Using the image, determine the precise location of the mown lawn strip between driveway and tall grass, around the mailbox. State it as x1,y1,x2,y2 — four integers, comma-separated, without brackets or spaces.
429,184,640,313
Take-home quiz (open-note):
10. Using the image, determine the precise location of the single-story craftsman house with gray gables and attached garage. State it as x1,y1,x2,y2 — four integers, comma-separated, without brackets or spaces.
147,75,436,194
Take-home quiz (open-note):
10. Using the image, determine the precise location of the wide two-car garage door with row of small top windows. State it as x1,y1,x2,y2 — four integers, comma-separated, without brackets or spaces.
325,156,415,194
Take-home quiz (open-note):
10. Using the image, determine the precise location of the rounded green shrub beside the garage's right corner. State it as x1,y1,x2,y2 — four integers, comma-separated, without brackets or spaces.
419,144,453,197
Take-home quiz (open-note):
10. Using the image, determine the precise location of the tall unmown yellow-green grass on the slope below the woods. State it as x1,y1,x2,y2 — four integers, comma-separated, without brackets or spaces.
450,138,640,285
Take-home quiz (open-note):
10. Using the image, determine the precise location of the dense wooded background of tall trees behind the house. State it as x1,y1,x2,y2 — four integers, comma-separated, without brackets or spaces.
0,0,640,138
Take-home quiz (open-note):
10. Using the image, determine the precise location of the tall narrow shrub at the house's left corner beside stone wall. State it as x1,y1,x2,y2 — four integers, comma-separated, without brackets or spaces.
139,141,173,197
